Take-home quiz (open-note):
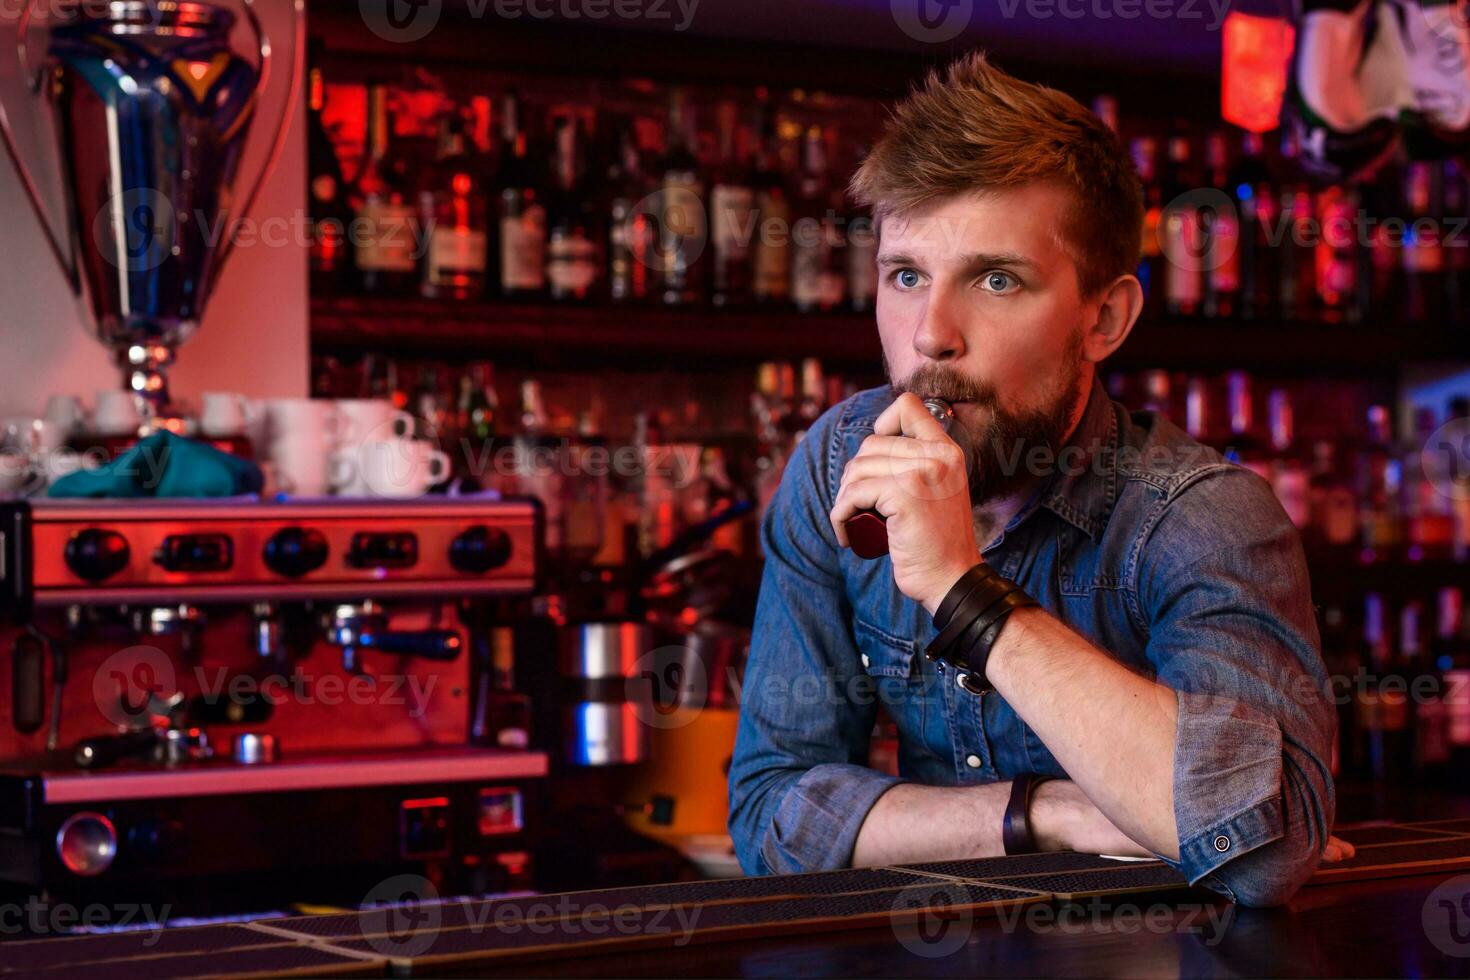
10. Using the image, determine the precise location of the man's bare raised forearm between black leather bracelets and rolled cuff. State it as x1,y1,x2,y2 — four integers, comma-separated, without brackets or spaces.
976,608,1179,860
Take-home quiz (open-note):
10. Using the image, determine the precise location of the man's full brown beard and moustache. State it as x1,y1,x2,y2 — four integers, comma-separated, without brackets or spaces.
883,331,1086,505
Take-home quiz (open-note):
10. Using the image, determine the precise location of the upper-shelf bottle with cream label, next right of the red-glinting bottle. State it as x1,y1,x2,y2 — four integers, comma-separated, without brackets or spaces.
494,93,547,297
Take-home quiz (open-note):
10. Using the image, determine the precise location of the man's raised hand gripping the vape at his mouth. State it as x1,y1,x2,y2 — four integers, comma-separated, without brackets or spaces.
829,392,980,614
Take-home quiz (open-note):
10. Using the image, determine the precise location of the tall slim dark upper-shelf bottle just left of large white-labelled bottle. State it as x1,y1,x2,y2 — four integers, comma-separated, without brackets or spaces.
657,87,710,306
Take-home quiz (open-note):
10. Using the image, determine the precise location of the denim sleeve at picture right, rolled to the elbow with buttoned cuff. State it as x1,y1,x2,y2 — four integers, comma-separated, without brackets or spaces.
1138,466,1336,905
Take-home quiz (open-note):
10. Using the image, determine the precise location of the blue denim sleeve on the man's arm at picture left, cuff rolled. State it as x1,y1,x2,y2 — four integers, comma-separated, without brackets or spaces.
729,406,903,874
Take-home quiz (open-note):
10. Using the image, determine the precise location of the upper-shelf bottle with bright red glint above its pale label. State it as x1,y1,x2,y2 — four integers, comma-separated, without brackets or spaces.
419,110,487,300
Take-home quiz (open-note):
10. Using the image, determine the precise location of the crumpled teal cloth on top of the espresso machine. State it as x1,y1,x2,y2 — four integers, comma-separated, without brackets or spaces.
47,430,263,497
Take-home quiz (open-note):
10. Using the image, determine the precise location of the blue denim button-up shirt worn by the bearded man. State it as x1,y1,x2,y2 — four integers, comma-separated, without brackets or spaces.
729,373,1336,905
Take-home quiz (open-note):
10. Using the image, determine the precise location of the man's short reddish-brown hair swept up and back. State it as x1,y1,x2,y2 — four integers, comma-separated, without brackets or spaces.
850,51,1144,297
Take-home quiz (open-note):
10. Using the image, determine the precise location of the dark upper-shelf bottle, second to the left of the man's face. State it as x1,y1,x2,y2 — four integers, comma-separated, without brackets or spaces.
791,126,847,313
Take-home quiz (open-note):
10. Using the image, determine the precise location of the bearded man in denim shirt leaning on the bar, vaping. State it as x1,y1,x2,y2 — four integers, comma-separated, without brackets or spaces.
729,54,1351,905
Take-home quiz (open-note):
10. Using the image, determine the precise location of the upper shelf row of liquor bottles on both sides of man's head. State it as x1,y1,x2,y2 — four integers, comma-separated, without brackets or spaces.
310,63,1470,373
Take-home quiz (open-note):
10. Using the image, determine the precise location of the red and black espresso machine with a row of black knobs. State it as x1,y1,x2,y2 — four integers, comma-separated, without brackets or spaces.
0,495,547,915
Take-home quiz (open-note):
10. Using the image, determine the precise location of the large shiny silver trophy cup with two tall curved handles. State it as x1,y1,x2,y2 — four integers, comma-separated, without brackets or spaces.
0,0,304,430
